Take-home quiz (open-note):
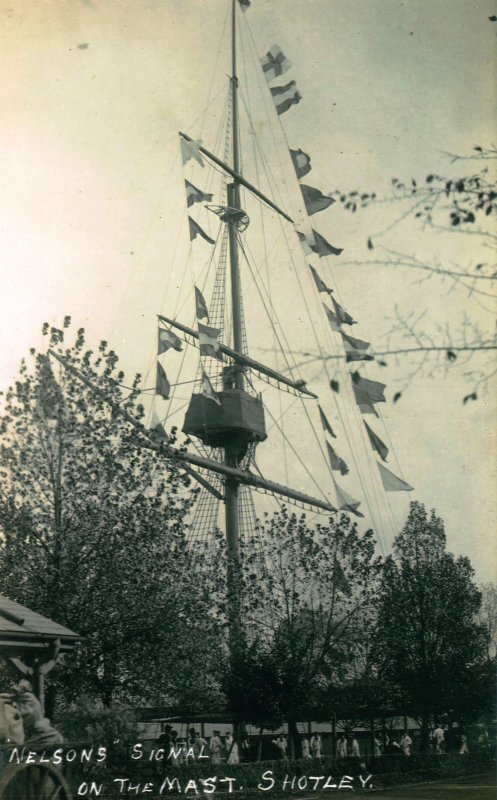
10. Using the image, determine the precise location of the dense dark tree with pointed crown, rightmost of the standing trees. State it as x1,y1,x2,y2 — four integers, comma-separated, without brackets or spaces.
375,502,485,749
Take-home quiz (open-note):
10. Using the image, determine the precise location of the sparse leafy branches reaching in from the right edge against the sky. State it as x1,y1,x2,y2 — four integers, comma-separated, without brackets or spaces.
292,145,497,403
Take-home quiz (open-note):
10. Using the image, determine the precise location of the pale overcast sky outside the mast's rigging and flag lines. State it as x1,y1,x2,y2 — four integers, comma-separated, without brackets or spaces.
0,0,497,580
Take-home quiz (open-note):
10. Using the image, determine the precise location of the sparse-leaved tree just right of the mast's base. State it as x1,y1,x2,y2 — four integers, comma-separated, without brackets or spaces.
229,509,380,754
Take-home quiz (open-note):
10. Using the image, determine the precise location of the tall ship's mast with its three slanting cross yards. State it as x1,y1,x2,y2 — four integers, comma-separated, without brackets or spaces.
49,0,336,680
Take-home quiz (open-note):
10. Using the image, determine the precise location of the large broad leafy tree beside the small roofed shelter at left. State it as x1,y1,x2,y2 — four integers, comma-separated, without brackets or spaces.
0,318,221,705
